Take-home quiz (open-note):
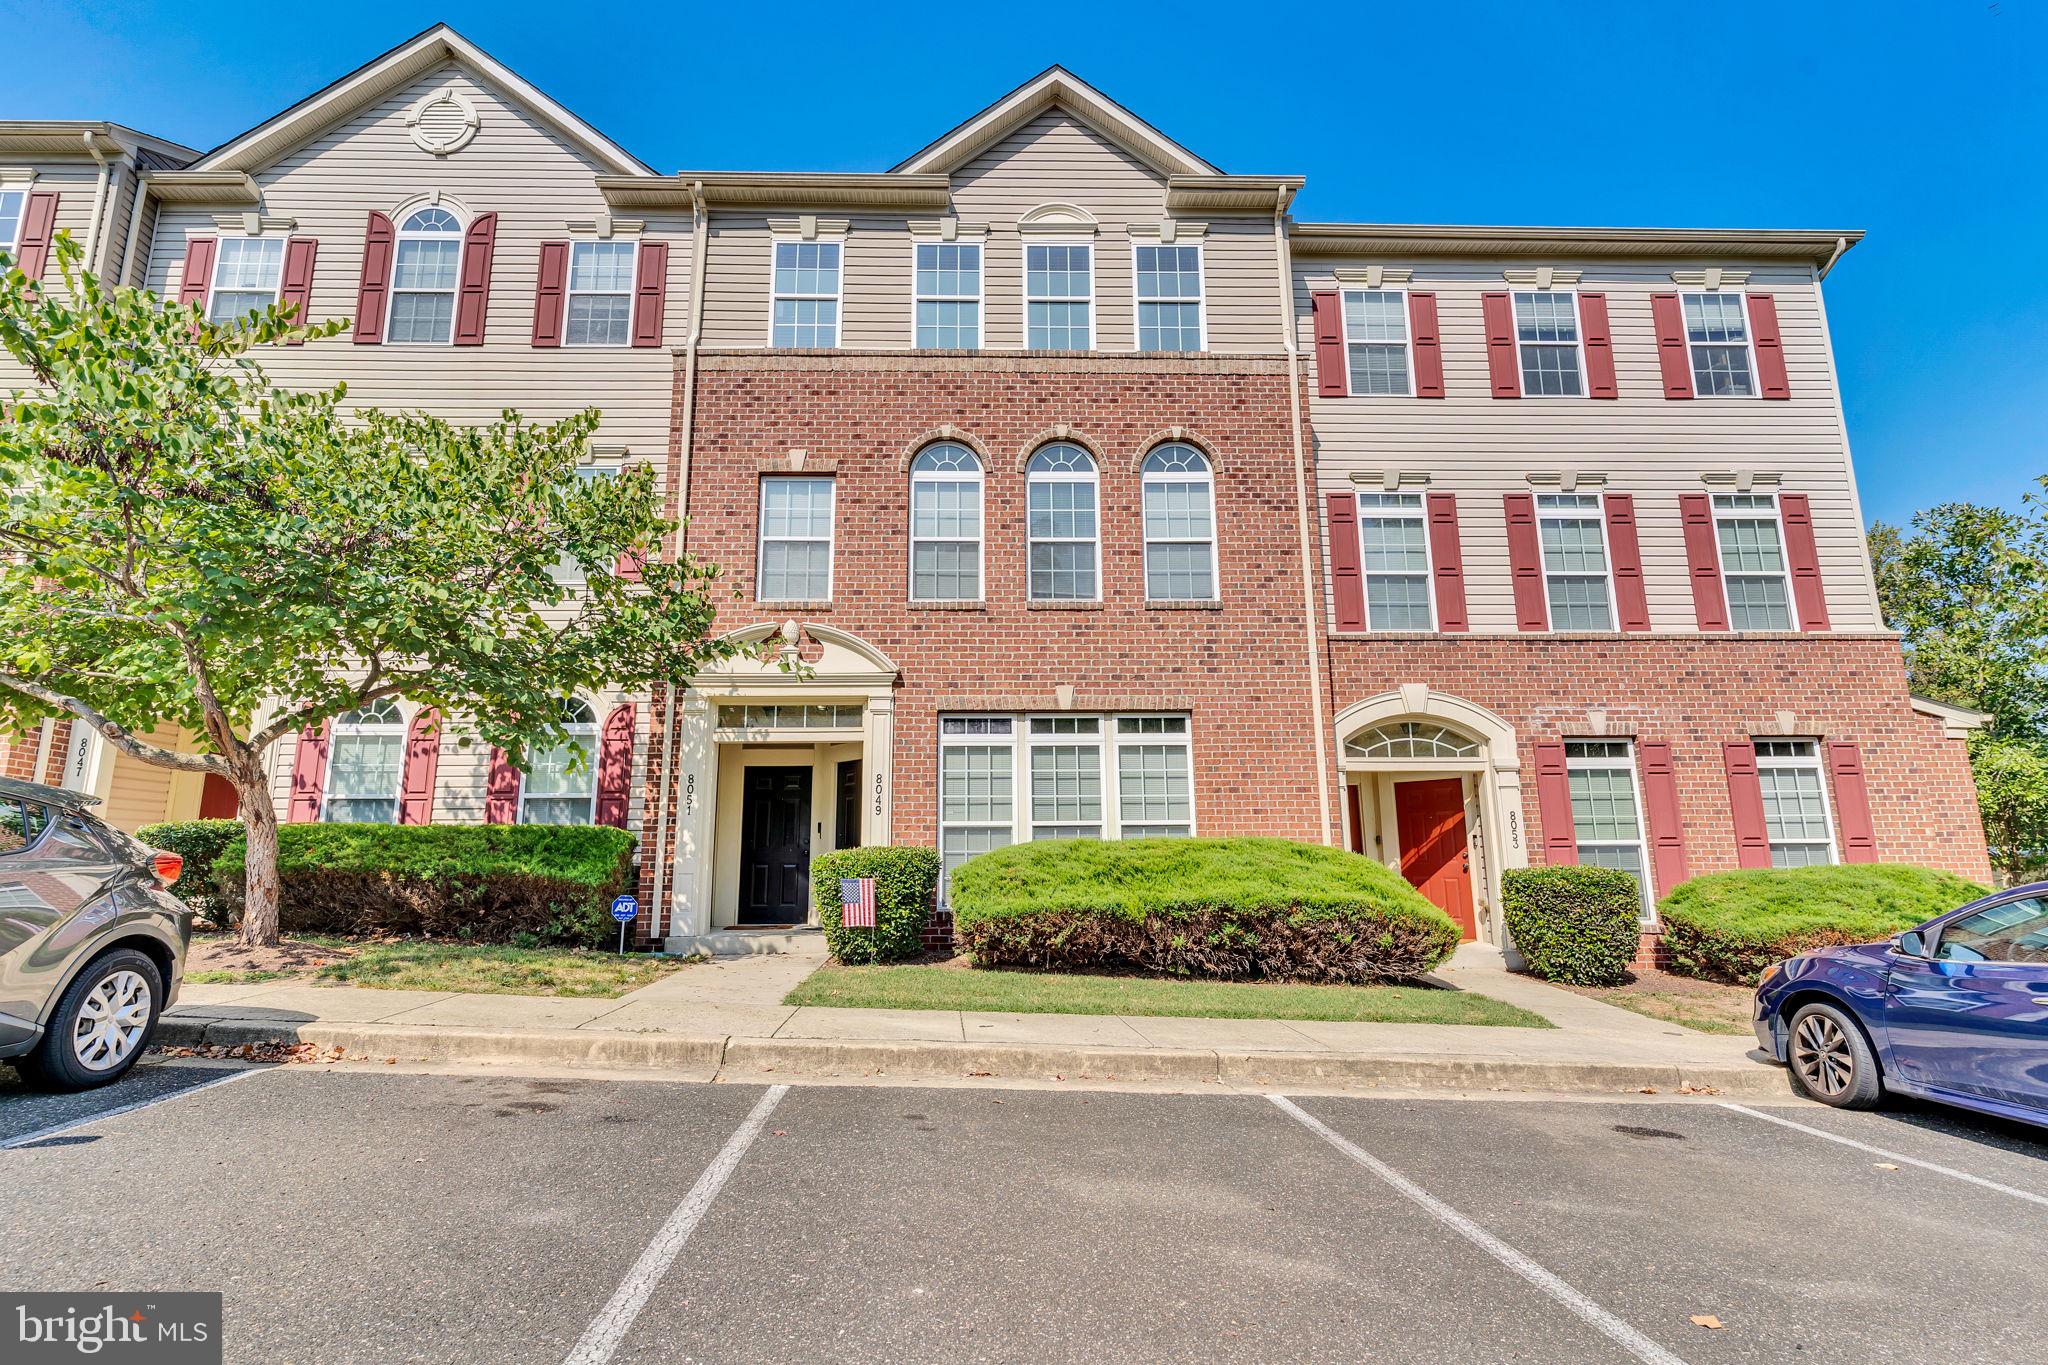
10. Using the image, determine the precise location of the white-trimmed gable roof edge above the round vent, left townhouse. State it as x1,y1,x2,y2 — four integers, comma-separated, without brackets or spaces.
190,25,653,176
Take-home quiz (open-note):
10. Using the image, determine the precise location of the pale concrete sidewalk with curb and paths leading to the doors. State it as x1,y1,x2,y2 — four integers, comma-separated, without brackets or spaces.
160,937,1786,1095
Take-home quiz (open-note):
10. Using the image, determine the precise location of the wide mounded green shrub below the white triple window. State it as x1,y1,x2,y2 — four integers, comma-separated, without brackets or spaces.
952,839,1458,982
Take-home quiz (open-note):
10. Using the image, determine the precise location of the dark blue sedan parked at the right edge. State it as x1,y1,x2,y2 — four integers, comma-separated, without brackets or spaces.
1753,882,2048,1126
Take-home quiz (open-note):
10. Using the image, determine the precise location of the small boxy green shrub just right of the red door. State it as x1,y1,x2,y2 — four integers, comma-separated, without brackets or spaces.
1501,868,1642,986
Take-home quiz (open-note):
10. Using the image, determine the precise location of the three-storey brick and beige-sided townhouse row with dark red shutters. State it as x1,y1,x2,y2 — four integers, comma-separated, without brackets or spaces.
0,27,1987,961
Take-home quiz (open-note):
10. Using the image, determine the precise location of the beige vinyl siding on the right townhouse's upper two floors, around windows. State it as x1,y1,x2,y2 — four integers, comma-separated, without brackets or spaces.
1294,258,1882,630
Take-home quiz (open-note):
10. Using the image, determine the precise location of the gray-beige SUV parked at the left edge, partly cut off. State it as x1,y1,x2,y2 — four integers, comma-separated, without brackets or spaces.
0,778,193,1091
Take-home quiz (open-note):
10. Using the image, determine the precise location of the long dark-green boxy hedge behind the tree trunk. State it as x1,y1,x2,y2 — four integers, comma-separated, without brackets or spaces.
213,825,633,948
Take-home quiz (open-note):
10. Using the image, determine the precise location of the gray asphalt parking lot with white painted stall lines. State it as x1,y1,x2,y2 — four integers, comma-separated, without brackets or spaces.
0,1064,2048,1363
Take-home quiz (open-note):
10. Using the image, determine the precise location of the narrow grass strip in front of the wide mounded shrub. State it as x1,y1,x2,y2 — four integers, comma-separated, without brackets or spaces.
782,966,1552,1029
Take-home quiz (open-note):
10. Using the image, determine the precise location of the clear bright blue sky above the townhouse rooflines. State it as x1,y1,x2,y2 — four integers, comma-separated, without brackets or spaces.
0,0,2048,520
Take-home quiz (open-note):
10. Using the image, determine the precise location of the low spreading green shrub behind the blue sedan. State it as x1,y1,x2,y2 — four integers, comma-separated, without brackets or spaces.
1657,864,1987,984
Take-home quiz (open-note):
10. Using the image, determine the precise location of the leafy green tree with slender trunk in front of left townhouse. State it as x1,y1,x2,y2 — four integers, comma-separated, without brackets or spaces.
0,235,739,943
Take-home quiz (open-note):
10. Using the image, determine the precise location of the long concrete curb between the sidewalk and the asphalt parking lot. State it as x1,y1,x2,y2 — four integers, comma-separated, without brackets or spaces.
156,1019,1792,1097
